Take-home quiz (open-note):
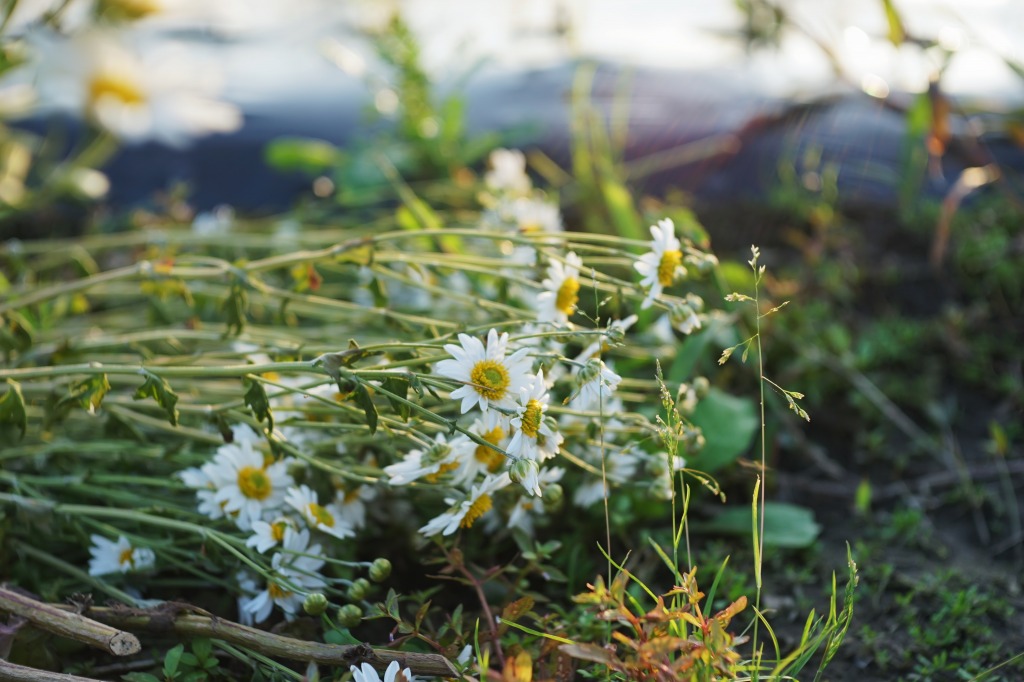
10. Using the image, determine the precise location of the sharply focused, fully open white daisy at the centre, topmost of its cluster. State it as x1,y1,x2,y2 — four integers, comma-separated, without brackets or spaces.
435,329,531,414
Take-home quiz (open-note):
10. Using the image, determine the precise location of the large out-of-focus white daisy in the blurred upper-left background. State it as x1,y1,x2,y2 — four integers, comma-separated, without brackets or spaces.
30,29,242,146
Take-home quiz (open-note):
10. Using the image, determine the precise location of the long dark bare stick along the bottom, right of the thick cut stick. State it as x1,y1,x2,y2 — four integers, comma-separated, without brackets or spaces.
70,602,459,677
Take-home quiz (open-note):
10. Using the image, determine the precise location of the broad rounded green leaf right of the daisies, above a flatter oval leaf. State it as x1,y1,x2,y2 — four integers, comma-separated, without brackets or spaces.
687,388,761,473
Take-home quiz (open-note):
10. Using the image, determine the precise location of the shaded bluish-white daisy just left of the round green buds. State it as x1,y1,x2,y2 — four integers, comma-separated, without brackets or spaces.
242,528,327,623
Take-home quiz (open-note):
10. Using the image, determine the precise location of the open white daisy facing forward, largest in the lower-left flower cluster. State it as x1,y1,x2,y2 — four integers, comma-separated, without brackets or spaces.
203,439,294,530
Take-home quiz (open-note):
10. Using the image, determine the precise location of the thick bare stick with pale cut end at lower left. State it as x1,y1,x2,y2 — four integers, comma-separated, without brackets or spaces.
0,587,142,656
